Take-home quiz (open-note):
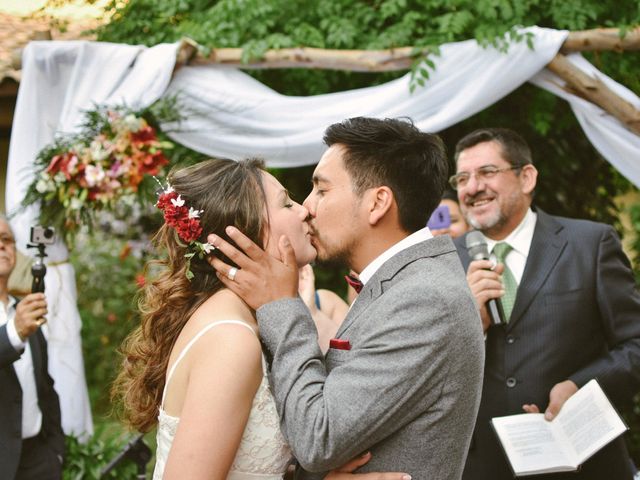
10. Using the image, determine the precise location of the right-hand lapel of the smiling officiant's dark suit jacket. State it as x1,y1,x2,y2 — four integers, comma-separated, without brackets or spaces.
507,209,567,331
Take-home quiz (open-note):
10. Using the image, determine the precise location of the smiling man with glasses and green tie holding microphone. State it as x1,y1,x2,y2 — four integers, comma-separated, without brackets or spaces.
450,129,640,480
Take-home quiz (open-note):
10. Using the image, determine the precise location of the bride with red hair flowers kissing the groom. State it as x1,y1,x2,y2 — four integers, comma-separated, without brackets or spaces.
114,159,406,480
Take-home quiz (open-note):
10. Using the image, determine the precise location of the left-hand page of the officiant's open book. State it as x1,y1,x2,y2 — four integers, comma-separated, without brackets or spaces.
492,413,576,475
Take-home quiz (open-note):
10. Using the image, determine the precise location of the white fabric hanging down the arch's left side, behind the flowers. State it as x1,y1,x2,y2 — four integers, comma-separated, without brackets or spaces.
5,42,177,437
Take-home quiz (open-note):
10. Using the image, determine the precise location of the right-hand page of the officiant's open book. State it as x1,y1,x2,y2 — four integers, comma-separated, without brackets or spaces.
552,380,627,464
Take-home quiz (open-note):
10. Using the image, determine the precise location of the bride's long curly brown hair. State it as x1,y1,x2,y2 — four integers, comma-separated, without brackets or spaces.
111,159,268,432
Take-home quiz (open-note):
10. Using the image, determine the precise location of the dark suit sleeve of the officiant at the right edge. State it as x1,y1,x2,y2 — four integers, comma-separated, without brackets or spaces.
570,227,640,404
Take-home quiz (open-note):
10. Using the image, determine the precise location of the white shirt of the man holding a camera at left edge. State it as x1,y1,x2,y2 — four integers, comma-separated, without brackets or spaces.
0,297,42,438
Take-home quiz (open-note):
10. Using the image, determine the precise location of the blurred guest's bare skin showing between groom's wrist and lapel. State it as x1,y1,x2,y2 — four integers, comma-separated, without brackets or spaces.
298,265,349,353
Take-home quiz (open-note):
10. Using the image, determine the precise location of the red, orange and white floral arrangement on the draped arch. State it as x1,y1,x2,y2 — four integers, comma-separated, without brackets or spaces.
22,100,178,244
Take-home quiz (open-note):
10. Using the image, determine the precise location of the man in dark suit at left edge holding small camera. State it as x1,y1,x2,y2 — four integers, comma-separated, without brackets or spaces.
0,219,64,480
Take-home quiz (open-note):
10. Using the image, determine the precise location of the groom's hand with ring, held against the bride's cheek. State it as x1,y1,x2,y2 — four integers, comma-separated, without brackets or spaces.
207,227,298,310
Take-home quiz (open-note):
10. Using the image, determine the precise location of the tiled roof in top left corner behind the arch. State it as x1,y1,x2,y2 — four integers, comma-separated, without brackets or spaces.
0,12,98,83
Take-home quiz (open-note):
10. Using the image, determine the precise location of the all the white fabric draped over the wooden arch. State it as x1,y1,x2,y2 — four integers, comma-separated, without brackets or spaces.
6,27,640,433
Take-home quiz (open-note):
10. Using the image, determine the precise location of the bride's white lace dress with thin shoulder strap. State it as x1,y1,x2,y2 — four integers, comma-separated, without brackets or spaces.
153,320,292,480
